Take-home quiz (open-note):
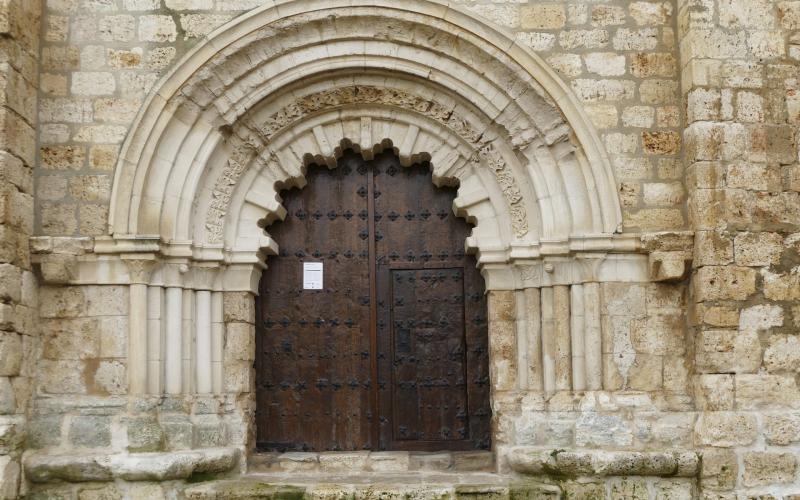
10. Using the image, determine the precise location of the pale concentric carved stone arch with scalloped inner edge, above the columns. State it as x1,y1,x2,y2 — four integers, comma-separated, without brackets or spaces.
110,0,620,262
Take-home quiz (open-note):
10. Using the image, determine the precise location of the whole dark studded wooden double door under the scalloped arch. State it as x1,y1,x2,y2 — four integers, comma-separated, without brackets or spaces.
256,151,491,451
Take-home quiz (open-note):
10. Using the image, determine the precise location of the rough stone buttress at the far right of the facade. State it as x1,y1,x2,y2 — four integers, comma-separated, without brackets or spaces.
678,0,800,498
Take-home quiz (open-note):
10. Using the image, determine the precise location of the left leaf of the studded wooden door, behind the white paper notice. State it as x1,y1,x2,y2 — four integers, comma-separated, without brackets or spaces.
257,156,372,451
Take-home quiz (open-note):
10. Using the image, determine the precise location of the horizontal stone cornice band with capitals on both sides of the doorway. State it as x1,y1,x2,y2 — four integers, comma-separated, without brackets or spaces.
31,232,693,293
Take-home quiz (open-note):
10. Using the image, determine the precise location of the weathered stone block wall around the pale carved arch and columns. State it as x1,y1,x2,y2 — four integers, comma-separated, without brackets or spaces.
7,0,800,499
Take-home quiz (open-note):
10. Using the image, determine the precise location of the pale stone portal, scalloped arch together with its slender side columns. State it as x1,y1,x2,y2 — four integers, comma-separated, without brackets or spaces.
95,0,647,466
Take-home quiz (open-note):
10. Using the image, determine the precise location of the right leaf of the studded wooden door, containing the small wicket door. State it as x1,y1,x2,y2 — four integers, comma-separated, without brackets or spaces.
373,154,491,450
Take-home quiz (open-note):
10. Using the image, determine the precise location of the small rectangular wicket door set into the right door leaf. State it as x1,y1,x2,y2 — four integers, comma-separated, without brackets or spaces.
391,268,469,445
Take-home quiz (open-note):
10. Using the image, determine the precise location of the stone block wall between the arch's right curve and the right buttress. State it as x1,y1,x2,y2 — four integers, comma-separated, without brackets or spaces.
459,1,685,231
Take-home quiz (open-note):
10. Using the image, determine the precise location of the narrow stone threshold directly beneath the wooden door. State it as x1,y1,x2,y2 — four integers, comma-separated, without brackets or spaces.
247,451,495,474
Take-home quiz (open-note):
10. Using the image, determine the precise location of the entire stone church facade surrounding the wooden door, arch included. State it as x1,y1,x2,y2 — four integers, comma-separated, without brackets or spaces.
0,0,800,500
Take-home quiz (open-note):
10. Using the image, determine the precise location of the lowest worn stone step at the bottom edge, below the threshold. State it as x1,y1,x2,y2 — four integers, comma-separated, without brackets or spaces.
184,473,561,500
